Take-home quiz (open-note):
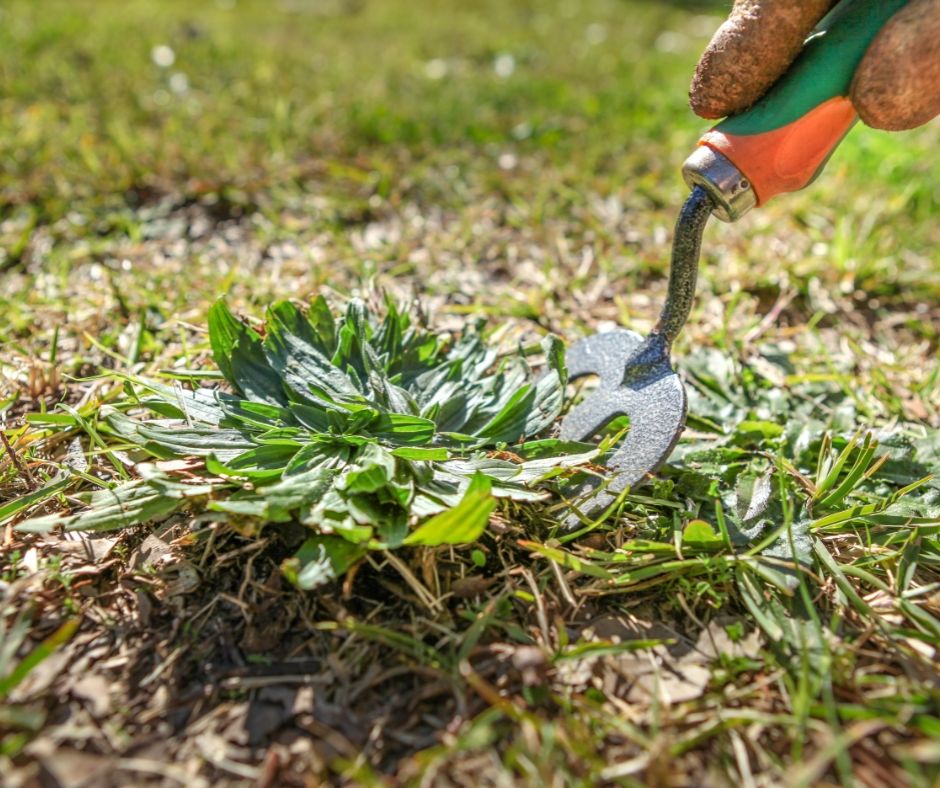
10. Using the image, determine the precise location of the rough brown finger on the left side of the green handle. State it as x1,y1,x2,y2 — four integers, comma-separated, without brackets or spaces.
689,0,836,118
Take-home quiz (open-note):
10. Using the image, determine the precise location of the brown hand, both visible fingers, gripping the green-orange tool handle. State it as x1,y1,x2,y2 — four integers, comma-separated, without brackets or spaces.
689,0,940,131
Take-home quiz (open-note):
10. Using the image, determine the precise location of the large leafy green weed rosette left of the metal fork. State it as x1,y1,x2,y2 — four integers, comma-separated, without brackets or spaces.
12,297,599,589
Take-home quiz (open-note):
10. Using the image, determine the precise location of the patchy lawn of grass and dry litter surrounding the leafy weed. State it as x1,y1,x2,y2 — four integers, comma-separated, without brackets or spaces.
0,0,940,786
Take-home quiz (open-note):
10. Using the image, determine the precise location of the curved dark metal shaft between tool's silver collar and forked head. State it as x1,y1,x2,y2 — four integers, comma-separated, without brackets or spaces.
653,186,715,352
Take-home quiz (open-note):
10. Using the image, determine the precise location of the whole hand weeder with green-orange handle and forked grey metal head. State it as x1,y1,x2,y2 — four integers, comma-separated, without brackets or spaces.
561,0,907,515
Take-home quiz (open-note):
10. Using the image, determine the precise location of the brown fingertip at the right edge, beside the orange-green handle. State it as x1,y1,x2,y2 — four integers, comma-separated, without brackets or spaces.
851,0,940,131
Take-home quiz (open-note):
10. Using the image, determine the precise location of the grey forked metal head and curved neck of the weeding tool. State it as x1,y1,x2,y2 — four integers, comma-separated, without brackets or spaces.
561,186,715,526
